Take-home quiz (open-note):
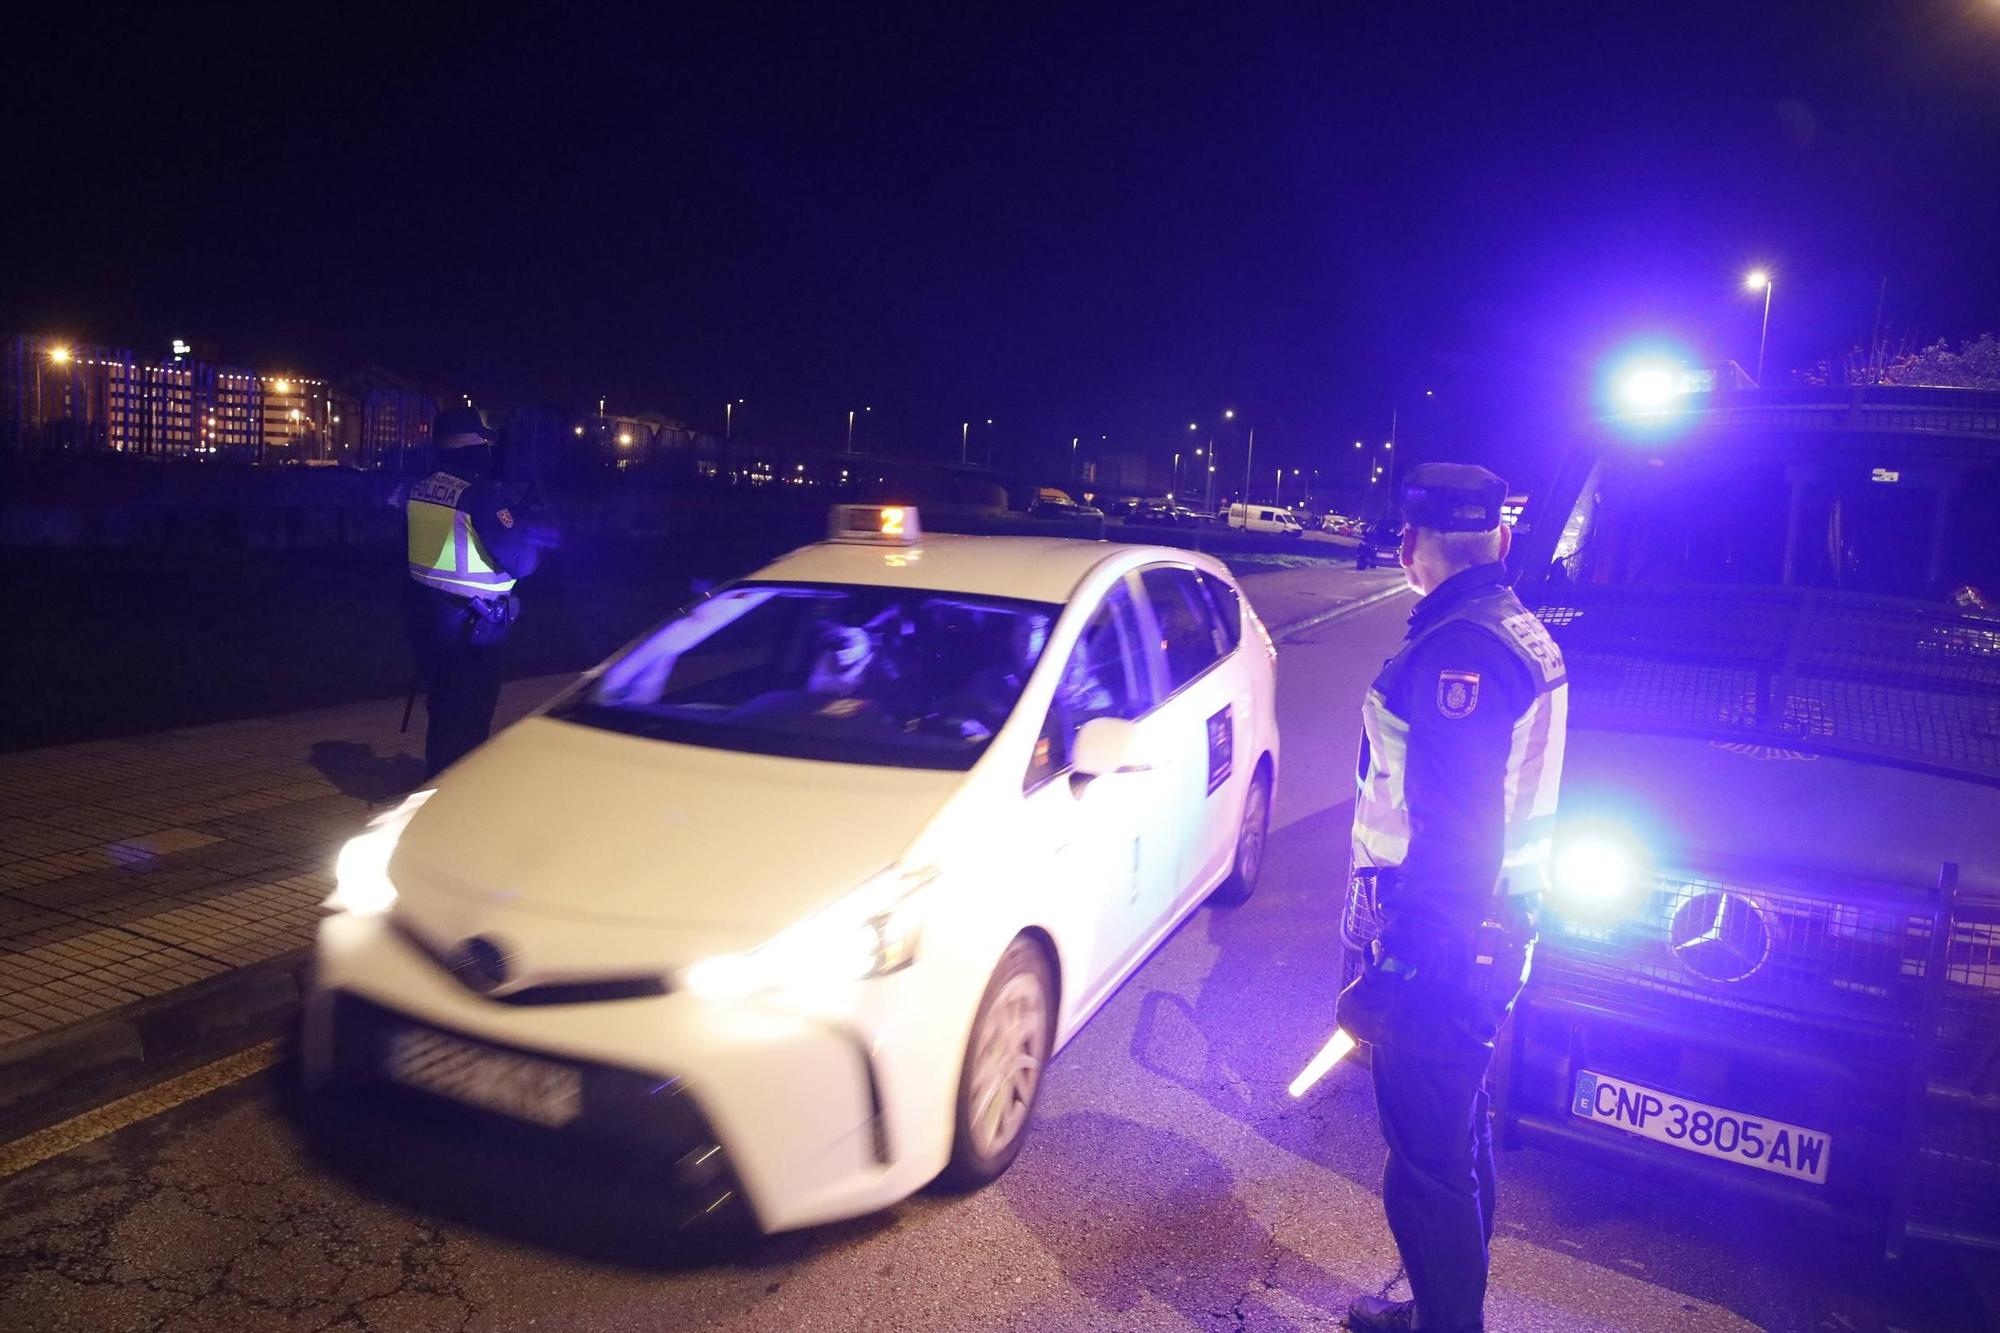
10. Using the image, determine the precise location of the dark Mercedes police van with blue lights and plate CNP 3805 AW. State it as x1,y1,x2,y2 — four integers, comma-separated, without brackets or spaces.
1346,374,2000,1251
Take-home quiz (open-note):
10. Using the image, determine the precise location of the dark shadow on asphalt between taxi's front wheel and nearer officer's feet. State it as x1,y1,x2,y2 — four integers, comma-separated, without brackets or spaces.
1000,1111,1358,1329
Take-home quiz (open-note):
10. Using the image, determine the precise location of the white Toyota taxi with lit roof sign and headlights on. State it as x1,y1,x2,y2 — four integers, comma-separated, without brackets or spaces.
302,506,1278,1231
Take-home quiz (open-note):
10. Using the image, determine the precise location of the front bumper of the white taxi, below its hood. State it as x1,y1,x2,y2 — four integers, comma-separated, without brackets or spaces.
302,915,948,1231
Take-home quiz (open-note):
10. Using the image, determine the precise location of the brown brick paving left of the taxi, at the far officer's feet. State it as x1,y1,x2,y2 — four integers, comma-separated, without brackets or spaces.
0,677,566,1047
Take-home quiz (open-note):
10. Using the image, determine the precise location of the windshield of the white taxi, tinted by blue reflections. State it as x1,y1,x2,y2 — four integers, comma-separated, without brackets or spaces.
550,582,1060,769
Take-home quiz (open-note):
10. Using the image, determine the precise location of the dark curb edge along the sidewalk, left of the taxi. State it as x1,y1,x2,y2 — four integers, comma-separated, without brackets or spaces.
0,949,310,1143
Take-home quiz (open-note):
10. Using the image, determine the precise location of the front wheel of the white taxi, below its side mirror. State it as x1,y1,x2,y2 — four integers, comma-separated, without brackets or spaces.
938,937,1056,1189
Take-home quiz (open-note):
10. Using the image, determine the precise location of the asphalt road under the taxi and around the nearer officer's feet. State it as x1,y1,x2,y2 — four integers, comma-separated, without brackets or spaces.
0,598,1982,1333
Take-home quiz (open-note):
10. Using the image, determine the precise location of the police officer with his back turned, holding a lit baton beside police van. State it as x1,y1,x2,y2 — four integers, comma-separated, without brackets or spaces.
1340,462,1568,1333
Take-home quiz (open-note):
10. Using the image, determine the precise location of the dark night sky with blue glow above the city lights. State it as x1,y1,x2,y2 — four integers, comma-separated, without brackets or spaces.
0,0,2000,480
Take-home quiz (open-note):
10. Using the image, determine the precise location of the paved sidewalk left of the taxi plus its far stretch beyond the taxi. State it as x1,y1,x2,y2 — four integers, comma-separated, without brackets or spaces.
0,568,1400,1139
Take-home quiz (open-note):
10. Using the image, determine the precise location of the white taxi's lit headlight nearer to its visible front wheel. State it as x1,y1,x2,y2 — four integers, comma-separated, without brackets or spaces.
680,869,936,999
